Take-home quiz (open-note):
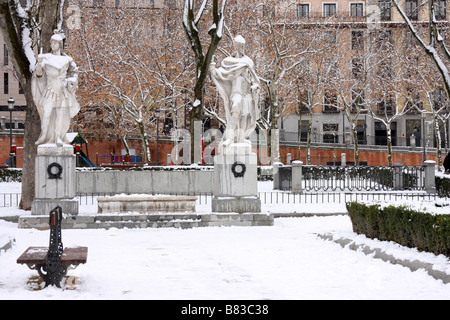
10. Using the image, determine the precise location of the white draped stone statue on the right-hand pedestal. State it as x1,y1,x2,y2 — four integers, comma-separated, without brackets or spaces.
210,36,261,154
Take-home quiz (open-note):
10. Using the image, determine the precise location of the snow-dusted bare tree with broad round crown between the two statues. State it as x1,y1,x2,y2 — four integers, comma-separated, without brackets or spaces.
72,8,190,162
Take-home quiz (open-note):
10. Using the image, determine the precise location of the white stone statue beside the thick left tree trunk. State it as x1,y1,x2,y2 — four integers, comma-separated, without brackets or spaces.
31,34,80,146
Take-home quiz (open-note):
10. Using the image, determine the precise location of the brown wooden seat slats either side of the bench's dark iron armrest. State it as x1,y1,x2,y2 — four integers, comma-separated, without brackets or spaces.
17,247,87,265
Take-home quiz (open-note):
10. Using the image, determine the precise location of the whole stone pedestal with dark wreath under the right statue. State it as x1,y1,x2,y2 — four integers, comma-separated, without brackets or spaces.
211,144,261,213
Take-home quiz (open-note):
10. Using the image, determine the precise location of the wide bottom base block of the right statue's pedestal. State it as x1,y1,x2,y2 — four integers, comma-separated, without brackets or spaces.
211,197,261,213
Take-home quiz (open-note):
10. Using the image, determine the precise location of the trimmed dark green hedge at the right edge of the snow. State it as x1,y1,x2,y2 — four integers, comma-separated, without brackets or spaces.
347,202,450,257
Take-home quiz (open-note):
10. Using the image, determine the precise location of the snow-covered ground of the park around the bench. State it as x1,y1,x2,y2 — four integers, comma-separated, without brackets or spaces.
0,183,450,300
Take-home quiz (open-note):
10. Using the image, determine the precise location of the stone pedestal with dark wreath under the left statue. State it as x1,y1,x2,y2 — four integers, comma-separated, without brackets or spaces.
31,144,78,215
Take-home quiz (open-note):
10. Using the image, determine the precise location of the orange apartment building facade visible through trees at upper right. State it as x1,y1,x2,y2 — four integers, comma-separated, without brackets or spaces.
279,0,450,154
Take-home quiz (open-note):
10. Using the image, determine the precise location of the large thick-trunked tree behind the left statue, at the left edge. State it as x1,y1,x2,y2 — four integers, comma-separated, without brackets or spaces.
0,0,64,210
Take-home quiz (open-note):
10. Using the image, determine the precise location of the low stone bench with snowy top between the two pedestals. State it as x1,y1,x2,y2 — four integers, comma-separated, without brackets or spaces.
97,195,197,213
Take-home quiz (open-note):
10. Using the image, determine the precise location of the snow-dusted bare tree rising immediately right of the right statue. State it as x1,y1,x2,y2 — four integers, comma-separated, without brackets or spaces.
234,0,315,162
